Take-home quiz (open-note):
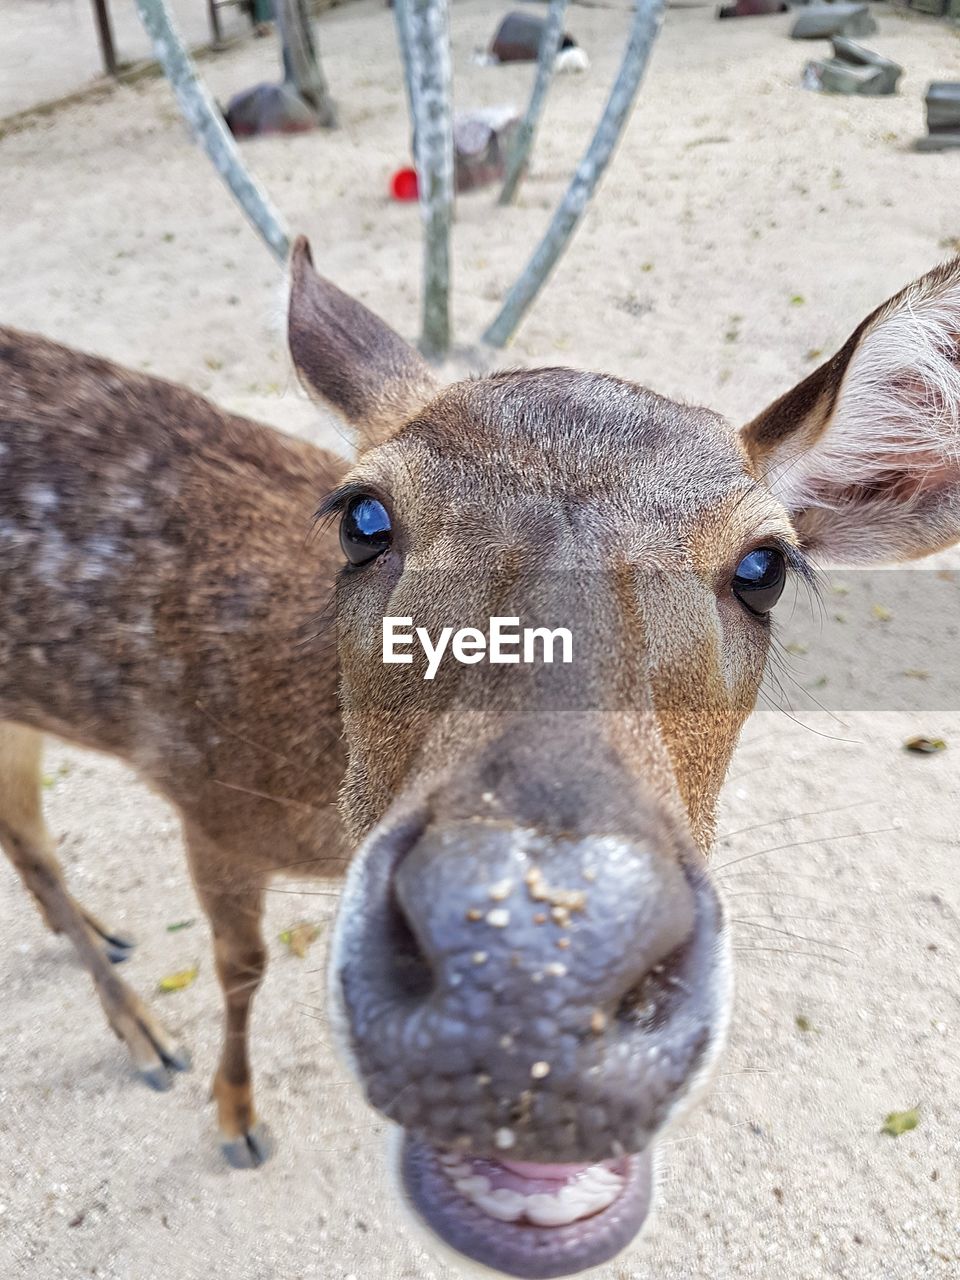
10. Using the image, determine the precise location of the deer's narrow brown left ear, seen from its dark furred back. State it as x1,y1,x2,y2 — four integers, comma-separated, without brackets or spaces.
287,236,439,448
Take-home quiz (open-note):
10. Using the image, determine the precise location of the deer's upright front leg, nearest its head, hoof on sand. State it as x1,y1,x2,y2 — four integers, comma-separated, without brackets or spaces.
184,826,273,1169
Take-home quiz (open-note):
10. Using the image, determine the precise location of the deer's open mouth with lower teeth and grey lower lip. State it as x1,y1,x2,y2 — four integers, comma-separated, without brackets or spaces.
401,1135,653,1280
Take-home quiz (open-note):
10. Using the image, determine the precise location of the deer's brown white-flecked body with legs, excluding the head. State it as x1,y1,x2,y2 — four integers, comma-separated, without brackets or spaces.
0,329,343,1162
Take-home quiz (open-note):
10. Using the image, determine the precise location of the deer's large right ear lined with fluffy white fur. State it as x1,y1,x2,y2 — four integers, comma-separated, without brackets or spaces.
744,257,960,564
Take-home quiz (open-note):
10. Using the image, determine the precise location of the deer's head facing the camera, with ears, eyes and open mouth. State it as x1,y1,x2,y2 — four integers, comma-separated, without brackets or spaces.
291,241,960,1277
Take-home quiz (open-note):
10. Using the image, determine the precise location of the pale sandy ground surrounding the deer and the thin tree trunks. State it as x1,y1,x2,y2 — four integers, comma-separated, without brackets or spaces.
0,0,960,1280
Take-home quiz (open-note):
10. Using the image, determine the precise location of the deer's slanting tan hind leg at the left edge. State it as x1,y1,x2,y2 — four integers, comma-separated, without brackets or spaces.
0,723,189,1089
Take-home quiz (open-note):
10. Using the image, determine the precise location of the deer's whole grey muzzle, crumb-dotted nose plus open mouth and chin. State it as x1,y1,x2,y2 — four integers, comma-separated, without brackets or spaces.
332,747,730,1280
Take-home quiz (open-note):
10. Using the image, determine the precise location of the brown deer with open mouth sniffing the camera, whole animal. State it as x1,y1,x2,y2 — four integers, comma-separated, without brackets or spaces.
0,238,960,1280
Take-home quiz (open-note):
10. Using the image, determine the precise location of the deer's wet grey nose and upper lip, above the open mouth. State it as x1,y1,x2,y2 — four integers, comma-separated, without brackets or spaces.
332,818,719,1162
